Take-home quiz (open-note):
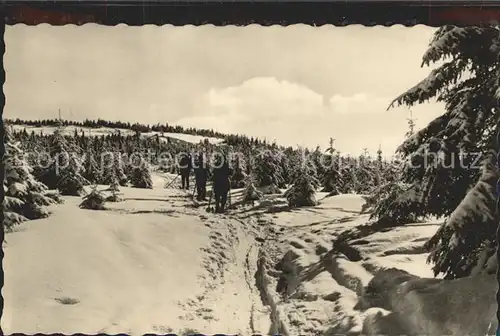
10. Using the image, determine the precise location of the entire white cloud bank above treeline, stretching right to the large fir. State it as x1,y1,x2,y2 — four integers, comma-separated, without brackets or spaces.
176,77,441,155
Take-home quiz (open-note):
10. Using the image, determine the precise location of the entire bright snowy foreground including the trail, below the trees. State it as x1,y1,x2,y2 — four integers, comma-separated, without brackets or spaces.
1,173,438,335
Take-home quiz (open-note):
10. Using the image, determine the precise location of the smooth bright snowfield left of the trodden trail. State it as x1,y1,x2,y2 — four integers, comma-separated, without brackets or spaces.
2,178,268,334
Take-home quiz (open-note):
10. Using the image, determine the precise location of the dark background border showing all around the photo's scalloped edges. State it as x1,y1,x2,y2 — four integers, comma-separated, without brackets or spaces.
0,0,500,336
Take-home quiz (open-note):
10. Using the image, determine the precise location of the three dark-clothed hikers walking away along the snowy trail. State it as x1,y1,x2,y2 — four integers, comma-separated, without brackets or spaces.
179,152,232,213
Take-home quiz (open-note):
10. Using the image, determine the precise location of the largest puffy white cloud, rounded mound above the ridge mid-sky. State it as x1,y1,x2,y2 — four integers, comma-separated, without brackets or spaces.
176,77,323,131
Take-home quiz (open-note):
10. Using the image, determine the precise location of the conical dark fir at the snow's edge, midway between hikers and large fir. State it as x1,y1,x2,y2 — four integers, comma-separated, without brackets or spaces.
284,150,319,207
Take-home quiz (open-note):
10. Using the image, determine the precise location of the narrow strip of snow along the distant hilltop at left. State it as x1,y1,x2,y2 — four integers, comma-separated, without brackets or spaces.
12,125,224,144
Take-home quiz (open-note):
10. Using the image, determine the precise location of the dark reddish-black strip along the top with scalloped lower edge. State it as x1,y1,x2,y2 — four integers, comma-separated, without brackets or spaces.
2,0,500,27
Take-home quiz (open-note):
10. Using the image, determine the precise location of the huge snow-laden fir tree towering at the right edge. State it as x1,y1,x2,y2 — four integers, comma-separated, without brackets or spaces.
376,26,500,278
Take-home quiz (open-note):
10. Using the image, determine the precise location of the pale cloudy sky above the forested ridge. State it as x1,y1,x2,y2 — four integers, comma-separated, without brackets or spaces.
4,25,443,154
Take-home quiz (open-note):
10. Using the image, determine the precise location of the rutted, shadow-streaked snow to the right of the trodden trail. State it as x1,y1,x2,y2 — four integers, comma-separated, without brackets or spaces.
235,195,439,335
